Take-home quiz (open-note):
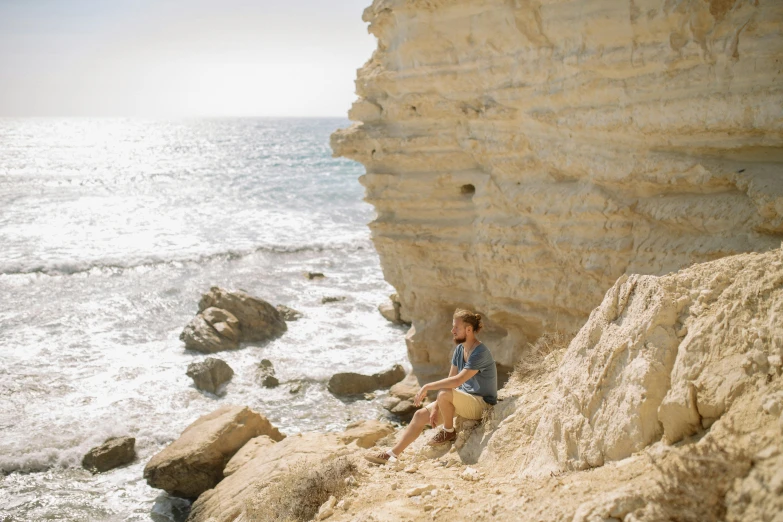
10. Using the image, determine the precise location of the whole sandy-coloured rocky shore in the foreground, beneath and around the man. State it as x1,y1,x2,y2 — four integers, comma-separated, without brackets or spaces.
127,249,783,522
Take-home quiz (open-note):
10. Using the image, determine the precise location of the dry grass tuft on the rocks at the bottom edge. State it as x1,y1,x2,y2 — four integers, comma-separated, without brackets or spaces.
246,458,357,522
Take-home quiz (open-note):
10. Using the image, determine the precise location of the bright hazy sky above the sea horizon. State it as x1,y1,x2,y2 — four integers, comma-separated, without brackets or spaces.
0,0,375,116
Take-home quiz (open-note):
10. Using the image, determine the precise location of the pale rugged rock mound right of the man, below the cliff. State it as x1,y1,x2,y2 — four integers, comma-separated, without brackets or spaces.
524,249,783,474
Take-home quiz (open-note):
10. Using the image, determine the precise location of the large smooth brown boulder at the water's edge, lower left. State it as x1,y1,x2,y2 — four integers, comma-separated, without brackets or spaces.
144,405,284,498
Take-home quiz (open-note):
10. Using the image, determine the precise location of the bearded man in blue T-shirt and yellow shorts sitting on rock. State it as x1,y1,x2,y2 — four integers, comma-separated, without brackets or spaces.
365,310,498,464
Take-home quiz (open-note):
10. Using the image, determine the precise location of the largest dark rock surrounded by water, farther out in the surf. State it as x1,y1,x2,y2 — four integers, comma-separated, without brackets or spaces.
179,287,288,353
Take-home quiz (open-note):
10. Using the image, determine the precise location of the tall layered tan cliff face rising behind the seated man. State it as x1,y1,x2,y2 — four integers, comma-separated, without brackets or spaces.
332,0,783,382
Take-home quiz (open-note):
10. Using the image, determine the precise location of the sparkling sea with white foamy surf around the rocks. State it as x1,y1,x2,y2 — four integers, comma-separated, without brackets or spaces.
0,118,409,522
